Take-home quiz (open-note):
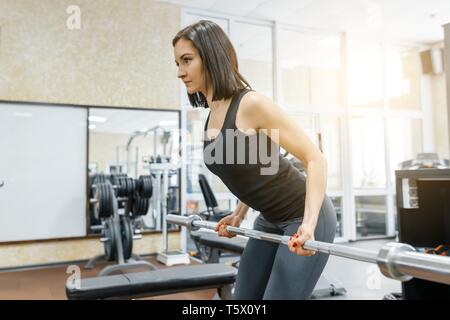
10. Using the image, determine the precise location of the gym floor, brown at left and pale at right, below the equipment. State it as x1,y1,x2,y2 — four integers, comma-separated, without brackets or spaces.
0,239,401,300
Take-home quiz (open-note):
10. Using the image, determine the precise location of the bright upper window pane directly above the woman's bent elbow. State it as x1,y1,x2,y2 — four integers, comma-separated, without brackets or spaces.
279,29,342,107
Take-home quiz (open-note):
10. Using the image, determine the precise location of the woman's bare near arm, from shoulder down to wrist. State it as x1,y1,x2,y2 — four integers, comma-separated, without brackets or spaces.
241,92,327,254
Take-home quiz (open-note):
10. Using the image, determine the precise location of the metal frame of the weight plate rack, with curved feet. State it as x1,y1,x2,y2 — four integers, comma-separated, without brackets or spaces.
84,181,157,276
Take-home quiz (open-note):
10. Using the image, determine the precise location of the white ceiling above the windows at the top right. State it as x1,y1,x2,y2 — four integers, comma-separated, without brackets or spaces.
159,0,450,43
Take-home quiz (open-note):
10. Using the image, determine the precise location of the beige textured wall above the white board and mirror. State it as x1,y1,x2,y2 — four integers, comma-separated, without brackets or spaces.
0,0,180,109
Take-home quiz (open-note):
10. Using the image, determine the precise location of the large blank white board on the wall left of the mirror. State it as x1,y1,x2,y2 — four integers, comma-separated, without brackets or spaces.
0,103,87,242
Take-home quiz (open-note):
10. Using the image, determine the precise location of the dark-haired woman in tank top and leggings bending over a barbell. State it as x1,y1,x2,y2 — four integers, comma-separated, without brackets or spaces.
172,20,336,299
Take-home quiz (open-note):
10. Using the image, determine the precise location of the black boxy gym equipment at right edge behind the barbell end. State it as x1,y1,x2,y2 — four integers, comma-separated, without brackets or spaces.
395,169,450,300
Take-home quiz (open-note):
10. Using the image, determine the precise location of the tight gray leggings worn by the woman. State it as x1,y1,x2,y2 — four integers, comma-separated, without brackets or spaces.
234,196,336,300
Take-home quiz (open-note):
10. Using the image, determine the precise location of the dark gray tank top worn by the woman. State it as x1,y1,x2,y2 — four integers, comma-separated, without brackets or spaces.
203,89,306,222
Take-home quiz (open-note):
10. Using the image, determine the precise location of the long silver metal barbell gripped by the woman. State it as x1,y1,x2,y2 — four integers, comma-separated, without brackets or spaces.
166,214,450,285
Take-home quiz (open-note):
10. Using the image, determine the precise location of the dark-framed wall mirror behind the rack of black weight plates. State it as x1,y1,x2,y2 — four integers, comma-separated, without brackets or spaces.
88,108,181,234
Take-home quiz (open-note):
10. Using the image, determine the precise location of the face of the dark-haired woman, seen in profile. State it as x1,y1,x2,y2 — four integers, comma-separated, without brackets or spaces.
173,38,205,94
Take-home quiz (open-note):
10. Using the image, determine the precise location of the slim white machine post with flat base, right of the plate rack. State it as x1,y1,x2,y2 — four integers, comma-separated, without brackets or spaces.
148,163,191,266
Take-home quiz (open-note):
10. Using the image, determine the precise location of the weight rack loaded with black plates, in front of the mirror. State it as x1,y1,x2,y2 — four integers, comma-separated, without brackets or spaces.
85,175,156,276
